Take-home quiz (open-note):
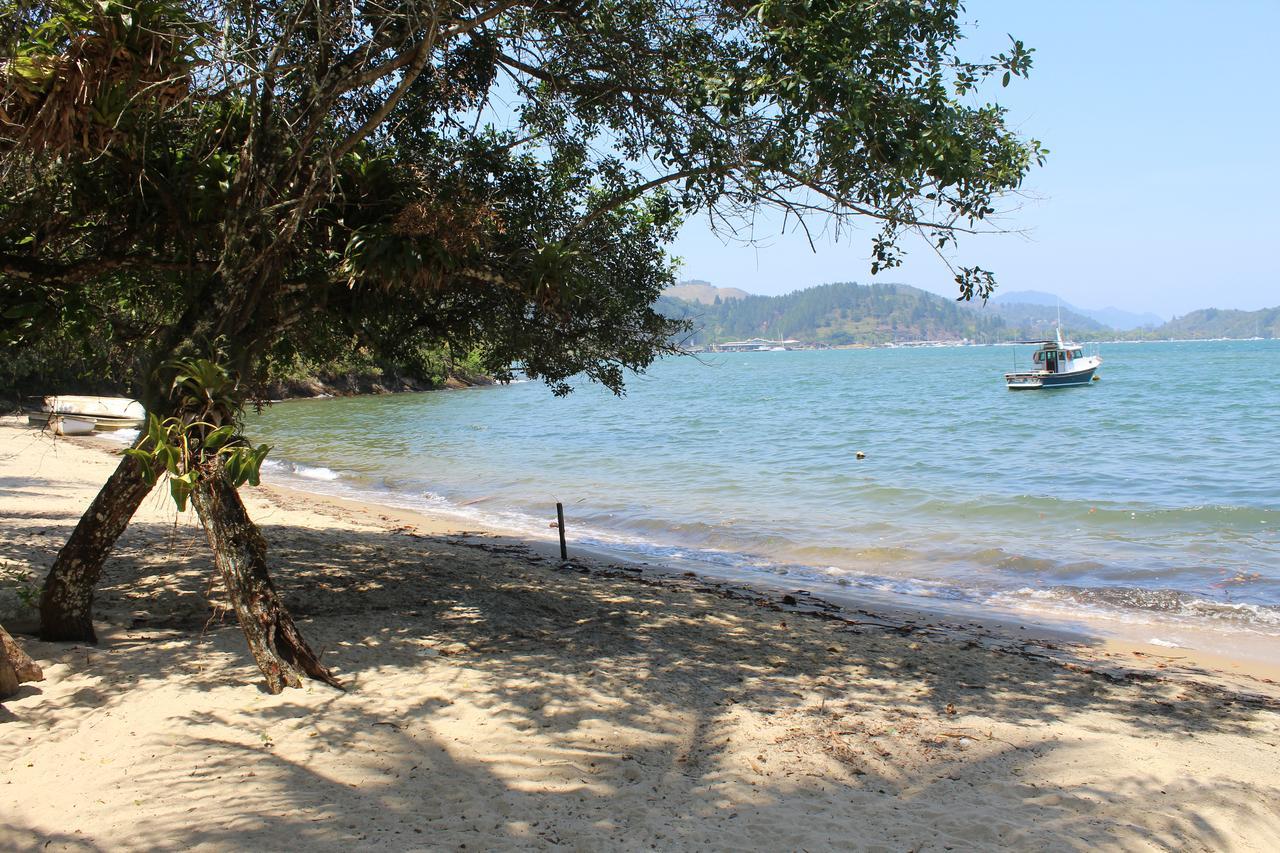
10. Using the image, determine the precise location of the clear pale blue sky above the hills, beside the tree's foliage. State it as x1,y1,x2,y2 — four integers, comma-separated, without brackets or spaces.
673,0,1280,318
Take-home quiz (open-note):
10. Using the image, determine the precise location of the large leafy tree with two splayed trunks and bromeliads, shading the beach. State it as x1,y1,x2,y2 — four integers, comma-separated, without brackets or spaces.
0,0,1043,689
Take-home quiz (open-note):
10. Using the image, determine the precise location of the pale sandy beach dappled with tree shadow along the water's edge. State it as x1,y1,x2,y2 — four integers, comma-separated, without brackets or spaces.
0,423,1280,852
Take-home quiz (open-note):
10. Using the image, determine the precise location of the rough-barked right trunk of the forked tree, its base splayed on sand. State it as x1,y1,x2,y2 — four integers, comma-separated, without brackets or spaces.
191,465,342,693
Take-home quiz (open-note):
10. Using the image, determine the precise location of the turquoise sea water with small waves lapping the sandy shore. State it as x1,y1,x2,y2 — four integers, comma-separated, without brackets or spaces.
251,341,1280,634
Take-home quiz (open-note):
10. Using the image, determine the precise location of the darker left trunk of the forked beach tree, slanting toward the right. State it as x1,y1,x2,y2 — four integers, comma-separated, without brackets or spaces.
40,445,151,643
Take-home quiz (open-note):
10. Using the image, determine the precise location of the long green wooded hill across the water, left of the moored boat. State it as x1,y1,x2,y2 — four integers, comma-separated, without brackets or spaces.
658,282,1021,346
